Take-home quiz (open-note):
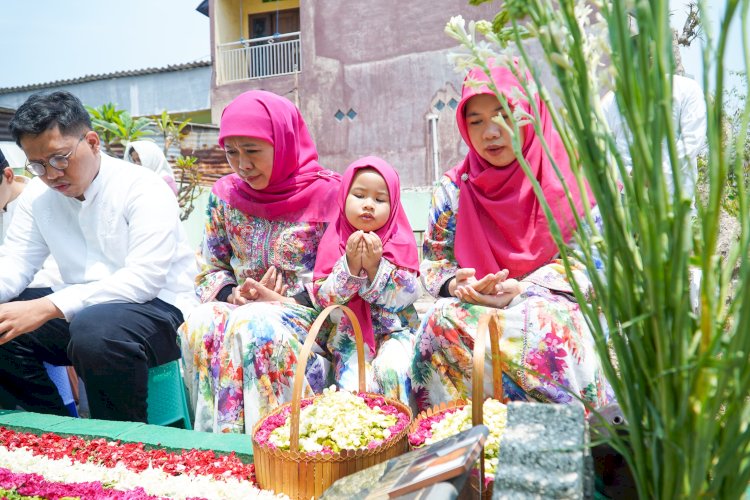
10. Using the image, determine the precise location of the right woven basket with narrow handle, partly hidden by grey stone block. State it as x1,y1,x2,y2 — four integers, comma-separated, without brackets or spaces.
409,314,503,500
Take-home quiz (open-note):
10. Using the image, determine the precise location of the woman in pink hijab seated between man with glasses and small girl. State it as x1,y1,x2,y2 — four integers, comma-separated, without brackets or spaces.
180,91,341,433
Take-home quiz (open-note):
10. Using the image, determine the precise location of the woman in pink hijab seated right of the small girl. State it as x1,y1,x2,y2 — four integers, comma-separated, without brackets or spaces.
412,60,611,409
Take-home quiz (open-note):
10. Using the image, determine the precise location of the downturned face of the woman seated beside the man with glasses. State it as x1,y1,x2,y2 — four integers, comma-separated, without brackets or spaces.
224,137,273,191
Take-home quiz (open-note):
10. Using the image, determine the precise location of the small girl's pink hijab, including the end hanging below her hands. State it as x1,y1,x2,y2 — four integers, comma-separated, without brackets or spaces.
313,156,419,354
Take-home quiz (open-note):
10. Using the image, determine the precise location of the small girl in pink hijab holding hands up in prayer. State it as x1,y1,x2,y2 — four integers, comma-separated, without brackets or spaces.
313,156,421,404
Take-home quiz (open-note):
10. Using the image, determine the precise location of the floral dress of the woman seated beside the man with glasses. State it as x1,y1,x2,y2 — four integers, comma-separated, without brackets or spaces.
179,193,330,433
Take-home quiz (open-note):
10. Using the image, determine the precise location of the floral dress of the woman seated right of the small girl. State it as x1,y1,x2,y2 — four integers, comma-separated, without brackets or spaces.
411,176,612,409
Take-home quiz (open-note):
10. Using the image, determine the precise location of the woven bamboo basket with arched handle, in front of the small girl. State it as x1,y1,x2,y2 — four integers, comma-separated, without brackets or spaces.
253,305,411,499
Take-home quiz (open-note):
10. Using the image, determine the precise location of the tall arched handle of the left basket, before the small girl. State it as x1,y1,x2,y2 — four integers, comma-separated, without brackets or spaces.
289,304,367,451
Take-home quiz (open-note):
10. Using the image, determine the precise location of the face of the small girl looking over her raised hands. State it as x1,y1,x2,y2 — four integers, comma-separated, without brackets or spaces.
344,168,391,232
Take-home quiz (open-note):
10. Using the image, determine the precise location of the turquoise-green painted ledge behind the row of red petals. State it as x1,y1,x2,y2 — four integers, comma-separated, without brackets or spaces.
0,411,253,462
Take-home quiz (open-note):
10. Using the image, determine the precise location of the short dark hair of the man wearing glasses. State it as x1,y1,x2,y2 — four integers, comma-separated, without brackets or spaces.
9,90,91,146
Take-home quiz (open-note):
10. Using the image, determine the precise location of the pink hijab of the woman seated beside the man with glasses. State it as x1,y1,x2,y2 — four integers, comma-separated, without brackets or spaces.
213,90,341,222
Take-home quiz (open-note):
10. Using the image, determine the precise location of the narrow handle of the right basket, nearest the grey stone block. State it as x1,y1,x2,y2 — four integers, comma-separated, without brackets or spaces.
471,314,503,425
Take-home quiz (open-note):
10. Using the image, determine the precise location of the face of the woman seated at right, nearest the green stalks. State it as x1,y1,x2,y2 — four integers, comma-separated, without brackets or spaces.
464,94,524,168
